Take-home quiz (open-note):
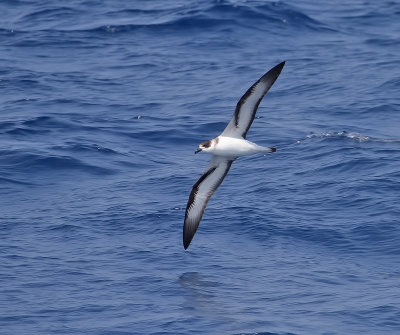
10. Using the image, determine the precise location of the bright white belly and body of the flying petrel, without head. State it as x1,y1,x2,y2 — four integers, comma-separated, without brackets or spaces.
207,136,271,157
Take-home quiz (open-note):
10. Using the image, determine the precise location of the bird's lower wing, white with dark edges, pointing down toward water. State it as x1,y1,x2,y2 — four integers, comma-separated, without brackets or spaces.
183,156,235,249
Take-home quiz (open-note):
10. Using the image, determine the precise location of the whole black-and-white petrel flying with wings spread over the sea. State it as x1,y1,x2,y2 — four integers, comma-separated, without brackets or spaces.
183,62,285,249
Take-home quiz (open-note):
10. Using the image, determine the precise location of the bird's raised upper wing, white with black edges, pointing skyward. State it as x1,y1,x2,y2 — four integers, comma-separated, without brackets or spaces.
221,62,285,138
